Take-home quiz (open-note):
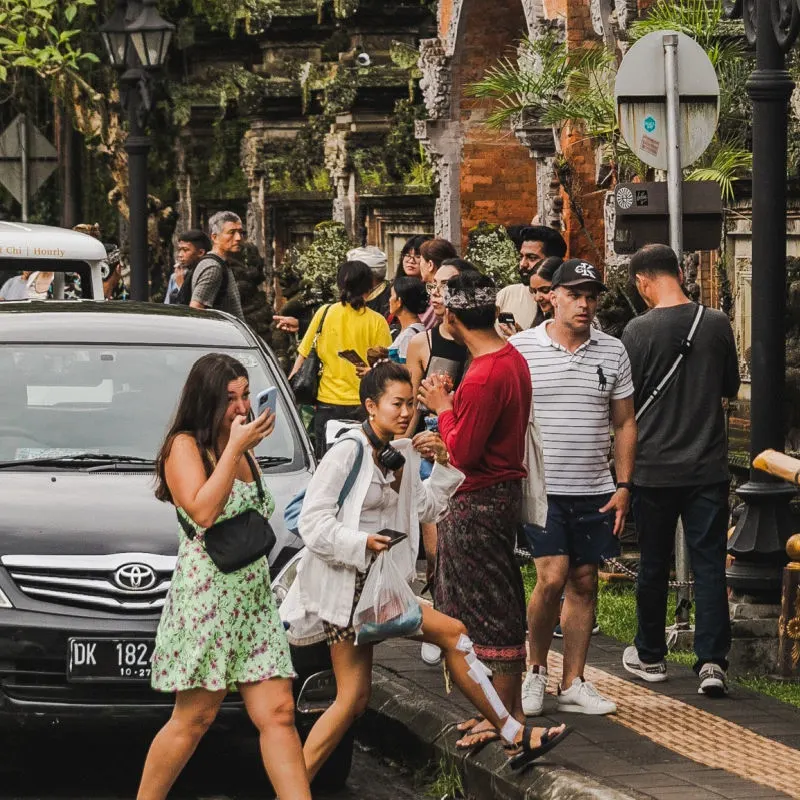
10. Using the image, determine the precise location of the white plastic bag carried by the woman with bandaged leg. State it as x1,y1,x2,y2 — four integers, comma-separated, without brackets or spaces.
353,550,422,644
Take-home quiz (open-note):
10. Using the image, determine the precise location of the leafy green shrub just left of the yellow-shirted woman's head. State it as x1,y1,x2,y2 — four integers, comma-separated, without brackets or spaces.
280,222,352,305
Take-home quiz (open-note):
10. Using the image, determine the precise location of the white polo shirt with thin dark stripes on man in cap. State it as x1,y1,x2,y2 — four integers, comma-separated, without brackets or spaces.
509,320,633,495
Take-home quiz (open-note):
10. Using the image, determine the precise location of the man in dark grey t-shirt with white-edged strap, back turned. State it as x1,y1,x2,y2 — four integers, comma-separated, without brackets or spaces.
622,244,739,696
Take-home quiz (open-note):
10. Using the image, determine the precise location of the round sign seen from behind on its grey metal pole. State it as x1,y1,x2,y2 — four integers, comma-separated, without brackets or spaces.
614,31,719,628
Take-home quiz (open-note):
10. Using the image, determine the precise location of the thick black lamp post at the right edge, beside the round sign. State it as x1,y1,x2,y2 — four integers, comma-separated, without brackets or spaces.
725,0,800,602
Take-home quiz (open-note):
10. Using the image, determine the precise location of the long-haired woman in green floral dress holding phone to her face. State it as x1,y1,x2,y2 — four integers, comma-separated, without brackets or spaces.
137,354,311,800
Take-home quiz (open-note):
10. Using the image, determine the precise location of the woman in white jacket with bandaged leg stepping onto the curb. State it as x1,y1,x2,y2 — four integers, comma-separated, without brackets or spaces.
281,351,569,778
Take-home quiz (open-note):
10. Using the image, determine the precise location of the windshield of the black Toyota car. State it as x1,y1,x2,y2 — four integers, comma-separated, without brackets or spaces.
0,344,301,465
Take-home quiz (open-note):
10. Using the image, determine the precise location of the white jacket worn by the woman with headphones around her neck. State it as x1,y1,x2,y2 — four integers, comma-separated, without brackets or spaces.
280,430,464,645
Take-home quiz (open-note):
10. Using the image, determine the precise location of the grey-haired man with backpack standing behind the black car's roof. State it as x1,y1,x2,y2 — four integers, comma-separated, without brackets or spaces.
189,211,244,320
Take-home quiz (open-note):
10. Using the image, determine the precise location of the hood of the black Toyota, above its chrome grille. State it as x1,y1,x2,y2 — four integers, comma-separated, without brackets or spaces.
0,470,310,561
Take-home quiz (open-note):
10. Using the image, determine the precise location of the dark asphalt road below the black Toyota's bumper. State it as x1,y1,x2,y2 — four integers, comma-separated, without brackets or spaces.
0,728,429,800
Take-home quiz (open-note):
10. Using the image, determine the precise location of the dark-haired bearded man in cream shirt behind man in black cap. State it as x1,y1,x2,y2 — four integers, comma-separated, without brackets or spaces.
497,225,567,337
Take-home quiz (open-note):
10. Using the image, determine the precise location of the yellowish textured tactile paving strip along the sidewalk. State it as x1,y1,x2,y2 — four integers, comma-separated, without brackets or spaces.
547,650,800,798
